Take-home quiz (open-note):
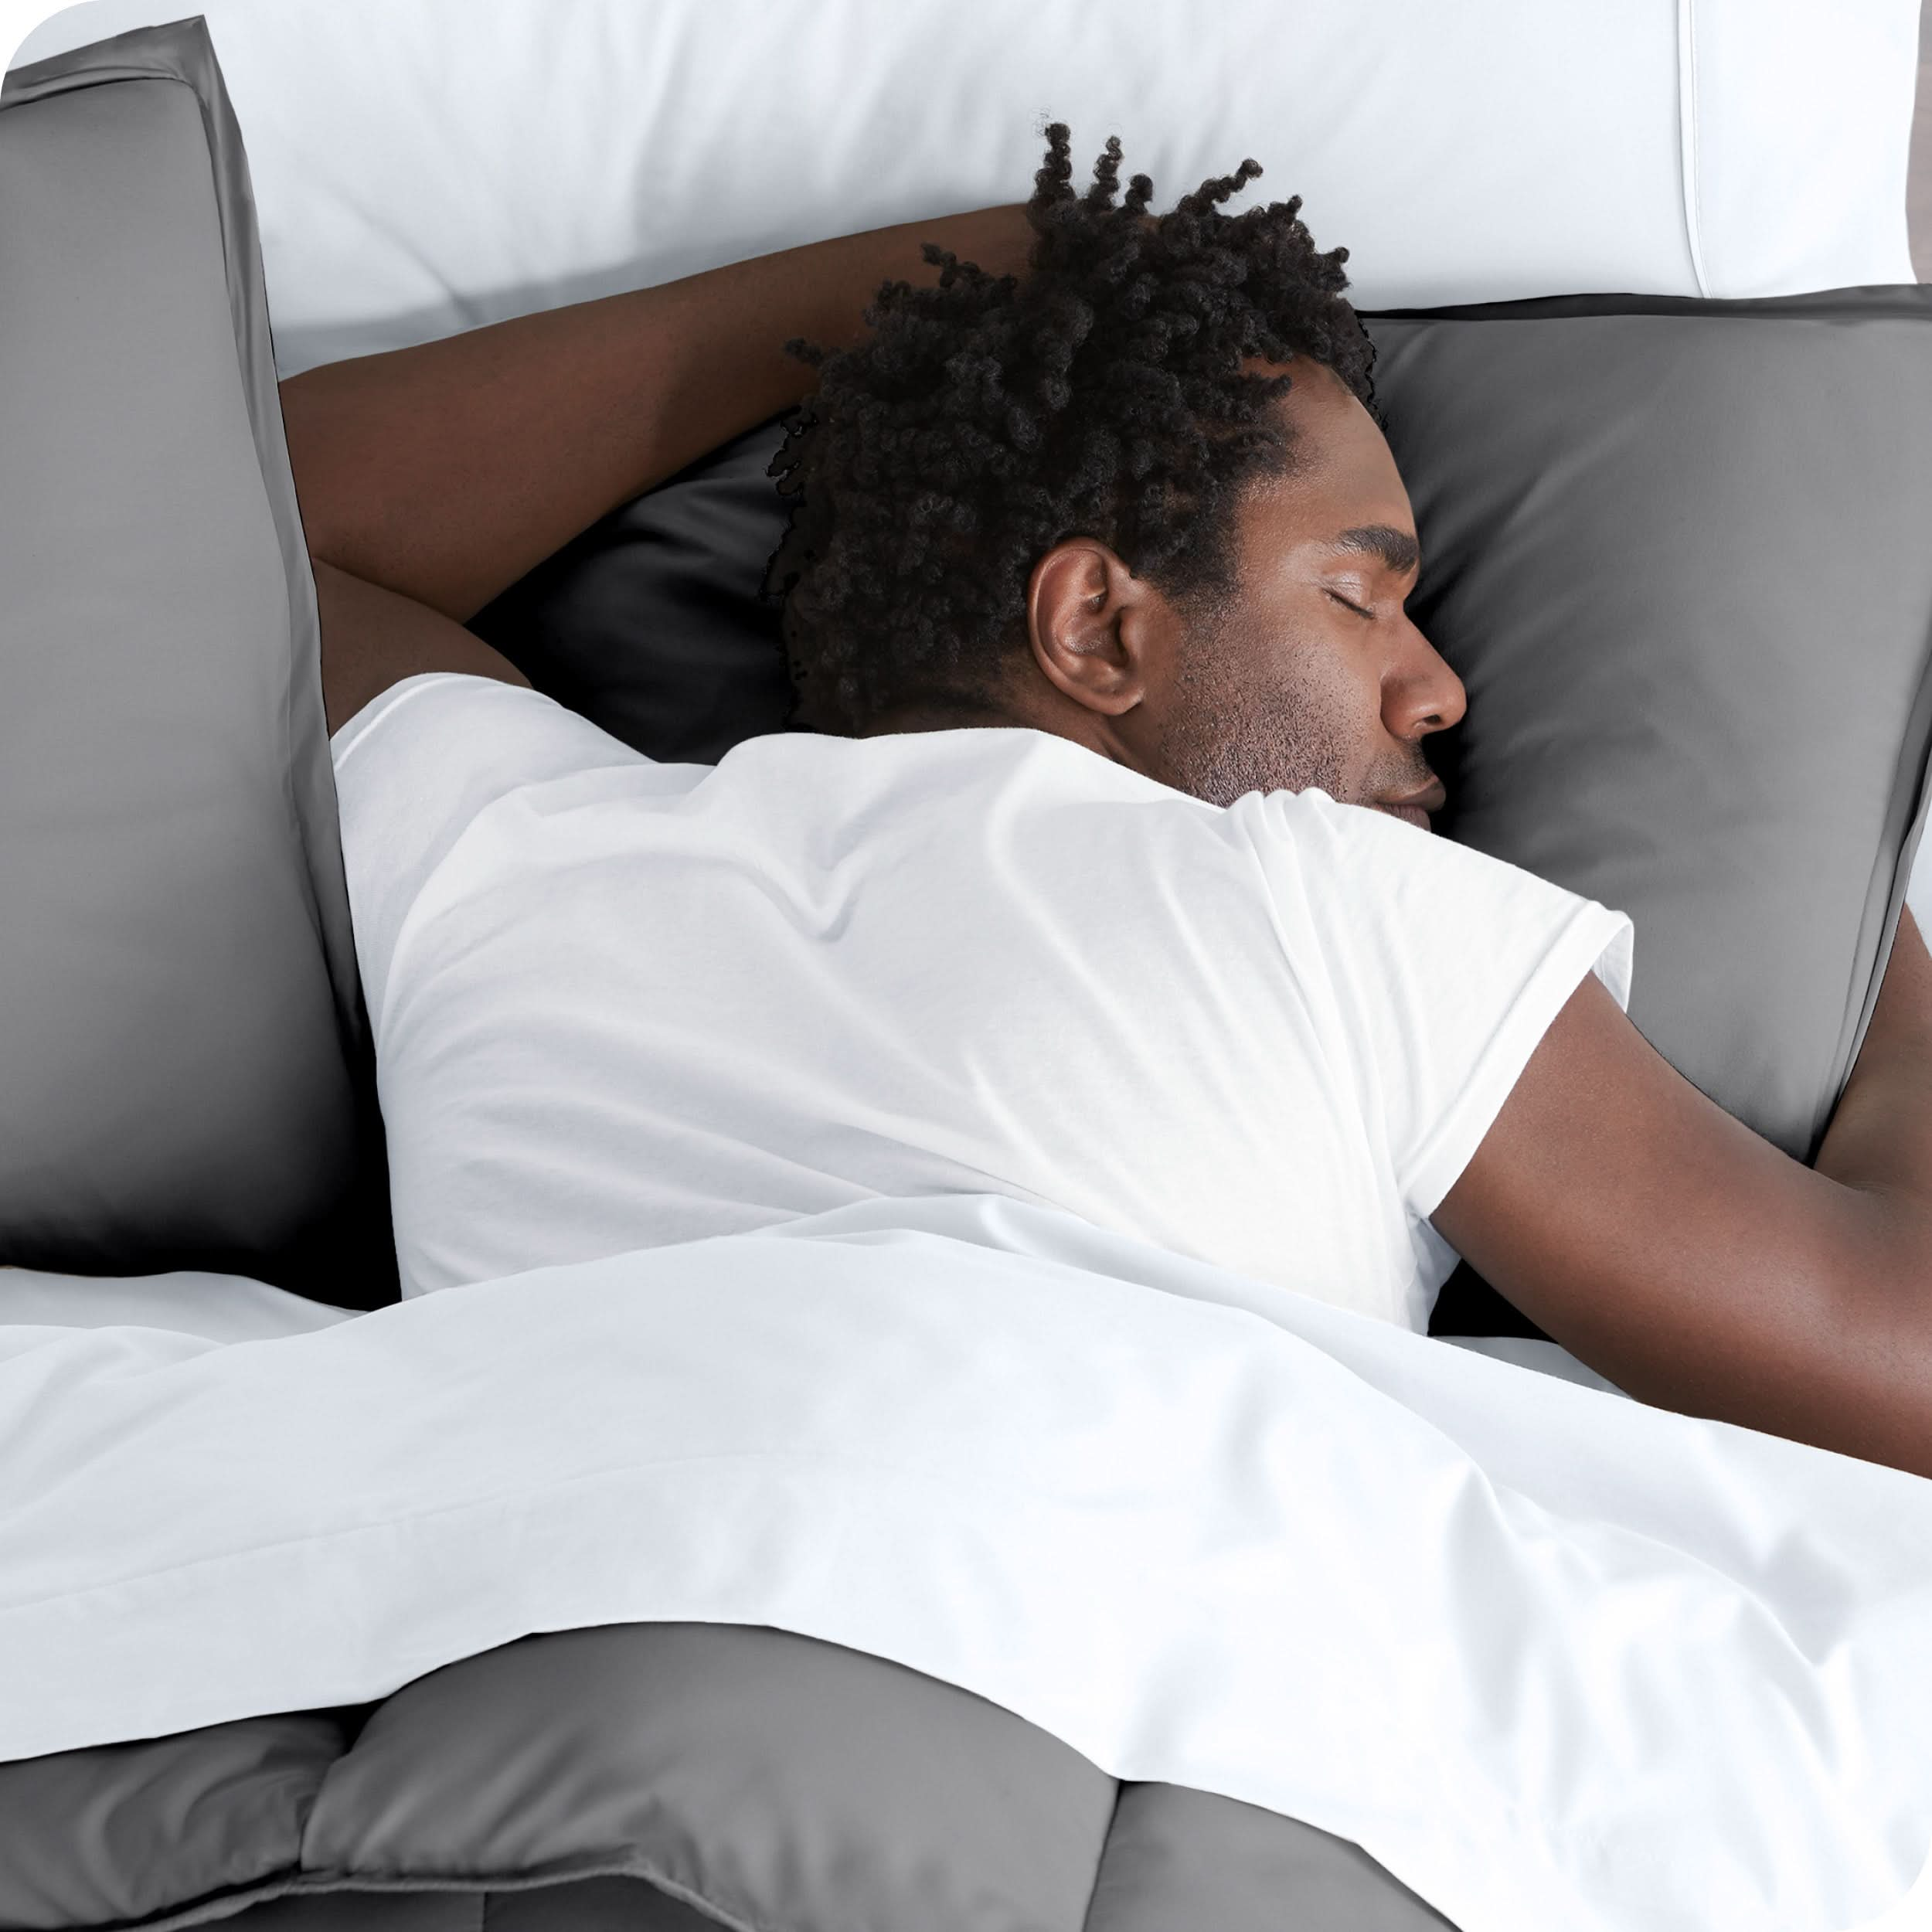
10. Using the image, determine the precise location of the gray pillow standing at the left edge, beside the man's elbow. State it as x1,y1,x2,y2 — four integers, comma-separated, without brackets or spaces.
0,19,394,1306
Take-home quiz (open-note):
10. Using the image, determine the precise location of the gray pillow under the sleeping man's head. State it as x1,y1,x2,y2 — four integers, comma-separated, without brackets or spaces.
475,286,1932,1335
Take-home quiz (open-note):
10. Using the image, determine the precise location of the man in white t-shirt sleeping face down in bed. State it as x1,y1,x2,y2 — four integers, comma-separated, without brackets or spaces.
282,126,1932,1475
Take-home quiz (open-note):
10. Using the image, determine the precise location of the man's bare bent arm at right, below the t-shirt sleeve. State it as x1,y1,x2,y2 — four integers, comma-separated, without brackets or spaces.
1430,912,1932,1476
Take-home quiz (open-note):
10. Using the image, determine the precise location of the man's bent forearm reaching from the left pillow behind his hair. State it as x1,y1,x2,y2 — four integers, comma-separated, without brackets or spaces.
282,203,1034,622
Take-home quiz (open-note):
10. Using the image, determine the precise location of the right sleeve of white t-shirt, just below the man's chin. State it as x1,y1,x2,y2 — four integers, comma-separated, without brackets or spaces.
1256,788,1634,1219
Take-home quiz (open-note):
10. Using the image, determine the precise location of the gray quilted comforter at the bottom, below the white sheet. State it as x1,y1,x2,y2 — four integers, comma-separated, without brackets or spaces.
0,1625,1449,1932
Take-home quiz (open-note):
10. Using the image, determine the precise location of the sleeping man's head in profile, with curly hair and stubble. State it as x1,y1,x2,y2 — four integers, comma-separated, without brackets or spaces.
767,124,1463,815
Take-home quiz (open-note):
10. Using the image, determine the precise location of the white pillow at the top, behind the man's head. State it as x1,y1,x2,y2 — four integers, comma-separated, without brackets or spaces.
15,0,1919,375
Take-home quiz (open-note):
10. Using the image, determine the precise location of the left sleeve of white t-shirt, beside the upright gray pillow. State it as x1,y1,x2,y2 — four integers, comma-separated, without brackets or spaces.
331,671,649,1030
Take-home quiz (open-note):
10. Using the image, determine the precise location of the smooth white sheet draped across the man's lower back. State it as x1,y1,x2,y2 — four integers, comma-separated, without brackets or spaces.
0,1196,1932,1932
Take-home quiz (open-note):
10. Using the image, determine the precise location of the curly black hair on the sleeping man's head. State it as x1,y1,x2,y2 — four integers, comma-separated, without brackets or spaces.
764,122,1379,734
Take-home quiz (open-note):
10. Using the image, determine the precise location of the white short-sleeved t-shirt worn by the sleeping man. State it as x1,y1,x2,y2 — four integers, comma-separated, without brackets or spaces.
335,672,1633,1329
